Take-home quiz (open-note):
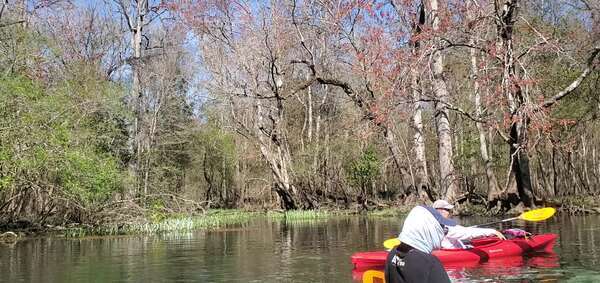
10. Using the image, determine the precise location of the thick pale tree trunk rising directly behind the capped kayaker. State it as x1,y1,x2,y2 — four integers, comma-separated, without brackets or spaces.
430,0,459,201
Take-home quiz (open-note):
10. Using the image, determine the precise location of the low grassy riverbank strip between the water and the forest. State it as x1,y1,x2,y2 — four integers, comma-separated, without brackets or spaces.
0,197,600,241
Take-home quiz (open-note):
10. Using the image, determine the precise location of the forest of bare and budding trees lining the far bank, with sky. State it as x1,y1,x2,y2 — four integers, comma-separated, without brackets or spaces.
0,0,600,231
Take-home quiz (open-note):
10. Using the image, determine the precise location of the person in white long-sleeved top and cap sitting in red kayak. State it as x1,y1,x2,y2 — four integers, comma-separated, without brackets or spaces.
432,200,506,249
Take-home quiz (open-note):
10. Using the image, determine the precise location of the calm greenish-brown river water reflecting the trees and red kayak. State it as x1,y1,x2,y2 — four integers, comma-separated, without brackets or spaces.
0,215,600,282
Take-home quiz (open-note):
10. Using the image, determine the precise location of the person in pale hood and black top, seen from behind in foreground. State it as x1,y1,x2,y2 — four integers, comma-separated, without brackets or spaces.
384,206,456,283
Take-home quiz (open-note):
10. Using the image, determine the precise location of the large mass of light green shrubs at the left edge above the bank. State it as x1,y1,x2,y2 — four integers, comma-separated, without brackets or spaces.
0,71,124,213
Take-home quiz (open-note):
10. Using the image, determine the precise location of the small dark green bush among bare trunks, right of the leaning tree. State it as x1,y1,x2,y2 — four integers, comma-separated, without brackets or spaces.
346,147,381,191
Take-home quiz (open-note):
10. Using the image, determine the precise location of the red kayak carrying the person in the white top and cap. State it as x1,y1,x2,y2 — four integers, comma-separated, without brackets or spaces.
351,234,557,269
